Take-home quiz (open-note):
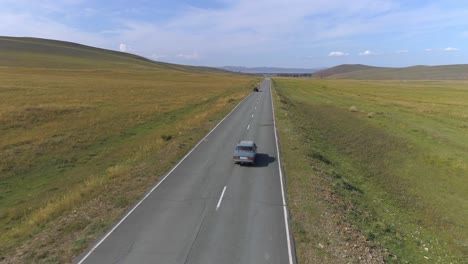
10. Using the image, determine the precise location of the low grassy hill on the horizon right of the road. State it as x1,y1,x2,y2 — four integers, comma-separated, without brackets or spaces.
314,64,468,80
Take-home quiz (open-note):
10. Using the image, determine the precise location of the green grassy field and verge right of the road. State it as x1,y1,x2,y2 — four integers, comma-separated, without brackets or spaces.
274,78,468,263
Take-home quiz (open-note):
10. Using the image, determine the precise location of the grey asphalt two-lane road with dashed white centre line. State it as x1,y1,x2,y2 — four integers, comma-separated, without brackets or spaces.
74,79,296,264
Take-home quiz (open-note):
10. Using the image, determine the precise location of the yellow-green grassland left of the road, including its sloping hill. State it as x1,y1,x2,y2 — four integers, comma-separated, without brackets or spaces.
0,38,260,263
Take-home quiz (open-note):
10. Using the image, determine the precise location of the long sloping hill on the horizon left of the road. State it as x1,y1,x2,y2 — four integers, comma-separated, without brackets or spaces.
0,36,225,73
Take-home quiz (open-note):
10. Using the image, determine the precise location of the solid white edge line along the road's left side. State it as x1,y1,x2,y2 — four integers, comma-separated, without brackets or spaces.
77,92,256,264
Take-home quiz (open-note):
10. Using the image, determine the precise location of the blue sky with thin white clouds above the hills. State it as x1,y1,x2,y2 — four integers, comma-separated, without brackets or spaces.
0,0,468,68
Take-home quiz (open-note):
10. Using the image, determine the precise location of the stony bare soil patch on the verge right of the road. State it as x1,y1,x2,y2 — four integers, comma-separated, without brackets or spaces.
290,163,389,264
